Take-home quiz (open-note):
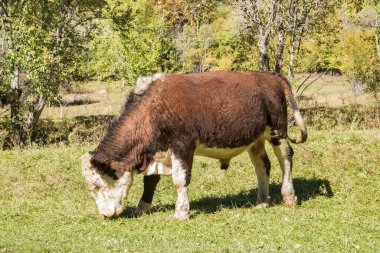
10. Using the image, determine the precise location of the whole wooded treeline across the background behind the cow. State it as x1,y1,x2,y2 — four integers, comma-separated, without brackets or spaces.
0,0,380,147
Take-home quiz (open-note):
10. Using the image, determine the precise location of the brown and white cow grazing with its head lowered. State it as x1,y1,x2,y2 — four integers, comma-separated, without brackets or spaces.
82,71,307,220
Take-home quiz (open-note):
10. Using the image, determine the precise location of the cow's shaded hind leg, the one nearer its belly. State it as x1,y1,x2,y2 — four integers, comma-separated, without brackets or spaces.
248,140,270,208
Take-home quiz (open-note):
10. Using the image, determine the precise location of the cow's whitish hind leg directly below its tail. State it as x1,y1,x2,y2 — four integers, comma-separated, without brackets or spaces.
273,139,297,206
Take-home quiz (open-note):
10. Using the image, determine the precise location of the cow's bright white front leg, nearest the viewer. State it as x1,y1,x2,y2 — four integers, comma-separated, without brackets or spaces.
172,154,190,220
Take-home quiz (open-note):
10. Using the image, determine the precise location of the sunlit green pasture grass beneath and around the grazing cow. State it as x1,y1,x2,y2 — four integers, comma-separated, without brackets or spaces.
0,129,380,252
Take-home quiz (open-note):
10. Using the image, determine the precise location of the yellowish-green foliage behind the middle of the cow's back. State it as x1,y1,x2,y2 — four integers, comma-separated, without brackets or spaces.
176,5,254,73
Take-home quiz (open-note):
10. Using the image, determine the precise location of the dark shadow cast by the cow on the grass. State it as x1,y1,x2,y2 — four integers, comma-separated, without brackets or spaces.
121,178,334,218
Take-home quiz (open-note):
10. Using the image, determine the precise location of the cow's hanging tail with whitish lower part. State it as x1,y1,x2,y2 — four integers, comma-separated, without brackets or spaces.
277,75,307,144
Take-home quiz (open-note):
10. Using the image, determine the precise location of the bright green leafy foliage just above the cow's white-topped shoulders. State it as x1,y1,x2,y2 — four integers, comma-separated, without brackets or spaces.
96,0,175,85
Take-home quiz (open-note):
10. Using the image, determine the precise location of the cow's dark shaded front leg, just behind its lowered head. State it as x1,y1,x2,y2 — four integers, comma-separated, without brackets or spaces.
135,175,161,216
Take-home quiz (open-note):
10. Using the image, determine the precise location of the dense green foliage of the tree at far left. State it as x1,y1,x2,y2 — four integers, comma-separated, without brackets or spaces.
2,1,102,98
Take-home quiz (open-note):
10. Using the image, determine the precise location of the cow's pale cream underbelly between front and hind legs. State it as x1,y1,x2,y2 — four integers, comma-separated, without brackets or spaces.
194,142,254,160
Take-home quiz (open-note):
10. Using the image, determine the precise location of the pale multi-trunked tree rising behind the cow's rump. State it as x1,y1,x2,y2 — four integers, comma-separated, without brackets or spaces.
235,0,336,75
